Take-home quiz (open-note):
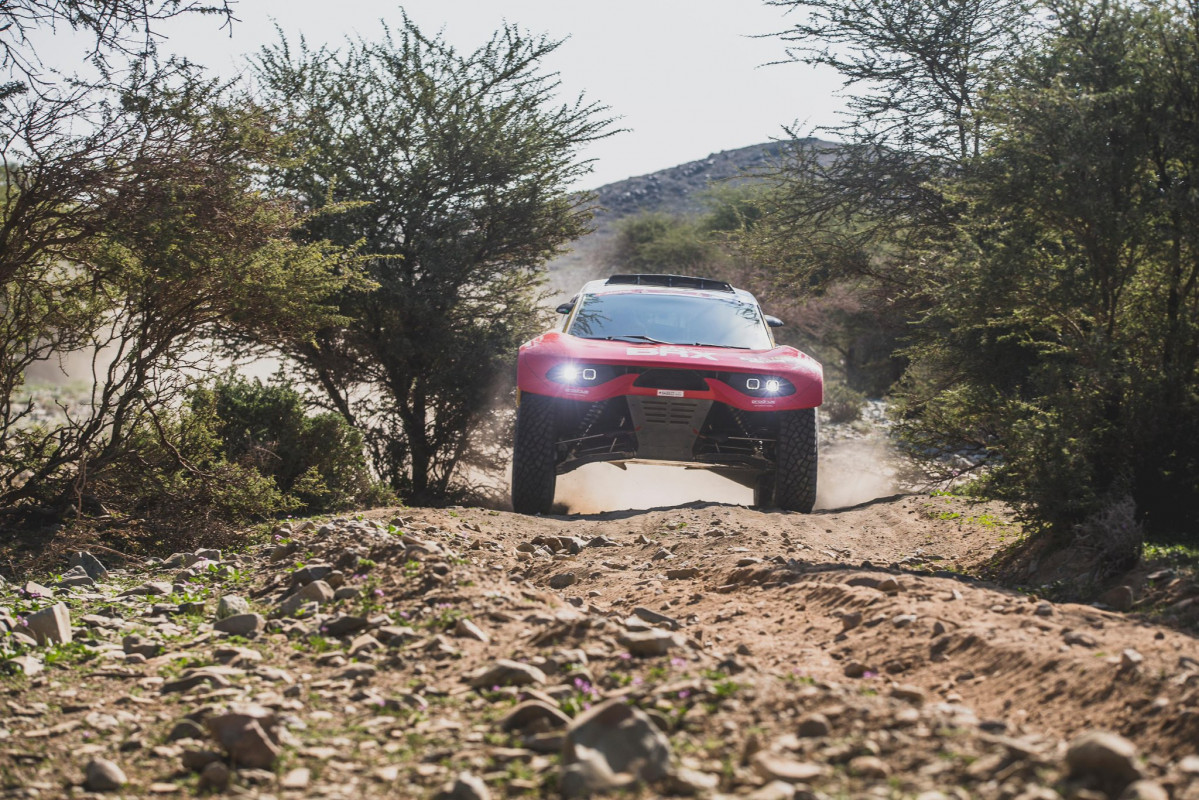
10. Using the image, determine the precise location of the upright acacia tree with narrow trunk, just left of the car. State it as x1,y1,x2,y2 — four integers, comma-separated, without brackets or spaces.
257,17,609,498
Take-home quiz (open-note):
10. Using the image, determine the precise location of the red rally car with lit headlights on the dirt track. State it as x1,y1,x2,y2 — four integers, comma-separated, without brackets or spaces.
512,275,824,513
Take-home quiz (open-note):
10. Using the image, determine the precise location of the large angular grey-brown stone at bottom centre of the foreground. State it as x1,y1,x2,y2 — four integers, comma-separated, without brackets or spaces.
560,698,671,798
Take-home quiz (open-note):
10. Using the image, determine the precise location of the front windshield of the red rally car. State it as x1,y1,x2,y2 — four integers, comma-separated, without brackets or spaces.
567,291,772,350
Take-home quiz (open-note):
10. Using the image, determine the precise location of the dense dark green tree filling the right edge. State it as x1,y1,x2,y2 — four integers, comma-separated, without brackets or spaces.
910,0,1199,544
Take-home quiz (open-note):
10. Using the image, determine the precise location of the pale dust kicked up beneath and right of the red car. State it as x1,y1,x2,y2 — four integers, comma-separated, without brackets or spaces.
556,435,899,513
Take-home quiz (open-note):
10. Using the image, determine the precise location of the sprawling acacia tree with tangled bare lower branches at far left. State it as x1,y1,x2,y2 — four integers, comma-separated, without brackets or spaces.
0,65,353,506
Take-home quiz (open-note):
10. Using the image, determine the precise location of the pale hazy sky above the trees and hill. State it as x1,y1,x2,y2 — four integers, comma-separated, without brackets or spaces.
39,0,843,188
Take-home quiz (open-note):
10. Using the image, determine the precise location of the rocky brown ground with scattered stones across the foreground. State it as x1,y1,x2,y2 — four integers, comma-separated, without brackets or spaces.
0,494,1199,800
